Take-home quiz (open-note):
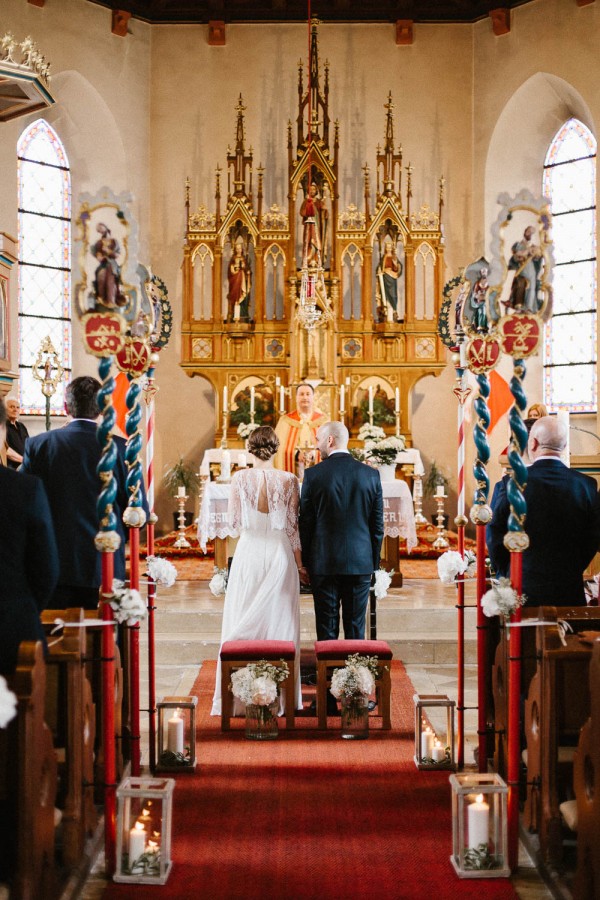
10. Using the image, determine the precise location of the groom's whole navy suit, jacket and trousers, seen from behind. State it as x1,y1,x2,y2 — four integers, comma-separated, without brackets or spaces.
300,452,383,641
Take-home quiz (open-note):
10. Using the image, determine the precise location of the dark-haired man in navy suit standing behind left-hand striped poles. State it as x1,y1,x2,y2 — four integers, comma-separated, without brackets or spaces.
21,375,134,609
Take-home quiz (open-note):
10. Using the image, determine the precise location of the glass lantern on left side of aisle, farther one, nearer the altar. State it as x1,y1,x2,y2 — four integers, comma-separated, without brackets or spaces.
156,697,198,772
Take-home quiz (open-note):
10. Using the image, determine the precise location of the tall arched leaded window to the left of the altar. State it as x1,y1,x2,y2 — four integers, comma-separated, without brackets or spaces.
17,119,71,415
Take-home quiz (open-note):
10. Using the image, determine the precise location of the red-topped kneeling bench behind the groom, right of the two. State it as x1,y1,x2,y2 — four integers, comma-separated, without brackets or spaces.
315,640,394,731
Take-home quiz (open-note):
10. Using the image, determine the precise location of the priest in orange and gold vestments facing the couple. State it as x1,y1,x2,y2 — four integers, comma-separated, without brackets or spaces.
275,381,329,480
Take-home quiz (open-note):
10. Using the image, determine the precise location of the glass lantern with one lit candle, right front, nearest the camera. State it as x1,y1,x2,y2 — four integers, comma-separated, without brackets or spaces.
450,772,510,878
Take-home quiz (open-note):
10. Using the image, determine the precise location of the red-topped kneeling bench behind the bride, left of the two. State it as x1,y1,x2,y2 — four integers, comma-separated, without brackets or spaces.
219,641,296,731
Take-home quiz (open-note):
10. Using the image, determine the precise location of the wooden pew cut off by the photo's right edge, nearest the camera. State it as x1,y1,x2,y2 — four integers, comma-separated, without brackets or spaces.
573,639,600,900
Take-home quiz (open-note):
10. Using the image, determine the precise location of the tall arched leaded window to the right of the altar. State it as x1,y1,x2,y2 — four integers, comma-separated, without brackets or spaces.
543,119,597,412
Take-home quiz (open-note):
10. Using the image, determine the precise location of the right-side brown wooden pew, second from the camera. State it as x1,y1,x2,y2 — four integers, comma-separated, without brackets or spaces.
524,626,591,866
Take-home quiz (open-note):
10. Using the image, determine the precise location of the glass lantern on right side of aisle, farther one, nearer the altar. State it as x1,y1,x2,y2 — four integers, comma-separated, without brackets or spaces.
413,694,456,770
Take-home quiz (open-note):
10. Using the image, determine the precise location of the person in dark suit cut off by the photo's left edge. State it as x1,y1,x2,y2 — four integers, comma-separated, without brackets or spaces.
0,400,58,675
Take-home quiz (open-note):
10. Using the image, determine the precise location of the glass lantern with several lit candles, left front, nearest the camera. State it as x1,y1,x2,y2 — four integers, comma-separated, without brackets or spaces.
114,778,175,884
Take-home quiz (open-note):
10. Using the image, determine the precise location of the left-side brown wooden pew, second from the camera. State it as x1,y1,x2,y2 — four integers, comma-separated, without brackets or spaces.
43,609,97,868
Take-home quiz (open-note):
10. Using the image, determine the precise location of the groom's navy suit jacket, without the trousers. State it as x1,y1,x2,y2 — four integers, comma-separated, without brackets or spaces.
300,453,383,575
